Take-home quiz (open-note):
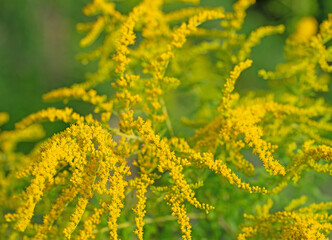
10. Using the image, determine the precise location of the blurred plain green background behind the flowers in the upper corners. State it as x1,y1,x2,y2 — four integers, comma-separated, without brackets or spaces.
0,0,332,129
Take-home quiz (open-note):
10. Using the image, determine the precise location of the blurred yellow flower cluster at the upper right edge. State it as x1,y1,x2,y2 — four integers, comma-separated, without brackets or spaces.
259,14,332,98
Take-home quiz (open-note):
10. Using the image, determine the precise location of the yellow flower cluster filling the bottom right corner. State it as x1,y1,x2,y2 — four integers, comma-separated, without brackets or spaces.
237,198,332,240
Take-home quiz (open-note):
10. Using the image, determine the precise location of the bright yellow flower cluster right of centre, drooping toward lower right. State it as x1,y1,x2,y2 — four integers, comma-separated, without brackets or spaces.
194,102,286,175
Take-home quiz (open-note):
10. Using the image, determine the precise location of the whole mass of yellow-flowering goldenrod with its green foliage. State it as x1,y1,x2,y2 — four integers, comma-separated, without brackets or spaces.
0,0,332,240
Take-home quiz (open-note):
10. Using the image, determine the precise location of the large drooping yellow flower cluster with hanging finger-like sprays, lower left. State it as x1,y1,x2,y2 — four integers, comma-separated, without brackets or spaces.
6,124,129,239
